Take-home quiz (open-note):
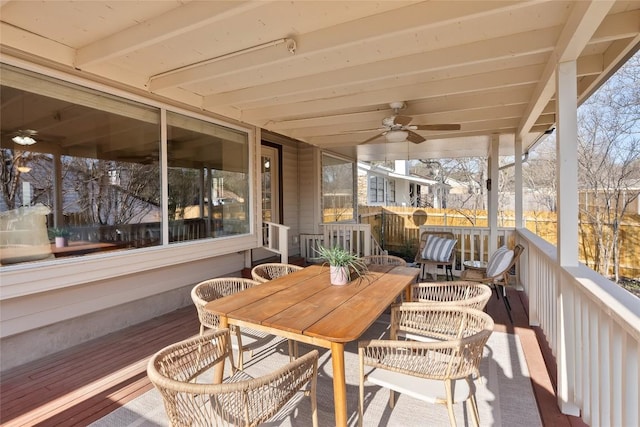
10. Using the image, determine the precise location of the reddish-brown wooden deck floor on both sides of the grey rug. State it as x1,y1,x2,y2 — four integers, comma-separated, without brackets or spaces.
0,282,583,427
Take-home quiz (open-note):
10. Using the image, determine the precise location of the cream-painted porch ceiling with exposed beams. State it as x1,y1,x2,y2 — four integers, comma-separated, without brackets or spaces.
0,0,640,161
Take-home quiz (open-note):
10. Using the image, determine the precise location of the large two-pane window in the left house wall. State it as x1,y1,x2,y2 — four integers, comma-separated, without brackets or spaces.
0,65,249,264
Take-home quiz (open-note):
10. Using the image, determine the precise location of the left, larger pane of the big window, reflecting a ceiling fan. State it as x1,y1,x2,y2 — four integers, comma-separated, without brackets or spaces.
0,65,161,263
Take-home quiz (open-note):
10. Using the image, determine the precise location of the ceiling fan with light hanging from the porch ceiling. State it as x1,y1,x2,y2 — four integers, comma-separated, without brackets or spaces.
360,101,460,144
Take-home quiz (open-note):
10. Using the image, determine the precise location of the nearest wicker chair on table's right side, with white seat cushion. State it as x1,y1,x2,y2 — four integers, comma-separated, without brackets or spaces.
358,303,494,426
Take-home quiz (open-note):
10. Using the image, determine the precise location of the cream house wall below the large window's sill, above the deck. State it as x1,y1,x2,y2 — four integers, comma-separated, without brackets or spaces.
0,252,244,371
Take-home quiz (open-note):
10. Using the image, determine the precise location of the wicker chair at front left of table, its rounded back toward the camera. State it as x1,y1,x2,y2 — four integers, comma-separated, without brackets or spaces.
147,328,318,427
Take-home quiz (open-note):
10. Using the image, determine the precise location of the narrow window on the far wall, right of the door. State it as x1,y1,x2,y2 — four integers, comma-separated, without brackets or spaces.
322,154,356,222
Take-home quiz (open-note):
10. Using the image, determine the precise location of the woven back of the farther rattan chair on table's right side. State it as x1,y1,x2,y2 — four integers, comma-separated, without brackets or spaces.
410,281,491,310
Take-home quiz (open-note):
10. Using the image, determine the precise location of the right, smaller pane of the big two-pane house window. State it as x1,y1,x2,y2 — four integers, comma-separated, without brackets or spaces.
167,112,249,242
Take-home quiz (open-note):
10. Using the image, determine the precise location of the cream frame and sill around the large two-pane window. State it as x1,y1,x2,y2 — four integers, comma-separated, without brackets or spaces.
0,57,260,300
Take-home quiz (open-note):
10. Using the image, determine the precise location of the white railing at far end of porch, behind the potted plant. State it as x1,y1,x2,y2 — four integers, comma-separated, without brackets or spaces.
300,223,386,259
